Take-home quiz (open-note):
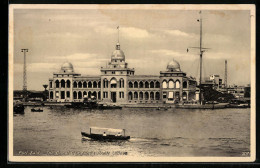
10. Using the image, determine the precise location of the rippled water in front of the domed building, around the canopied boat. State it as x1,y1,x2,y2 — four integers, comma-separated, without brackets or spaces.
14,107,250,156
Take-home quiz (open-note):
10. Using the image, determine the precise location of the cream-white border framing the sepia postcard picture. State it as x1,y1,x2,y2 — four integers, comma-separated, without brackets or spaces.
8,4,256,162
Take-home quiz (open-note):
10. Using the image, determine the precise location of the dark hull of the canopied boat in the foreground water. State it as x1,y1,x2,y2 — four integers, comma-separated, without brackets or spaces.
81,132,130,141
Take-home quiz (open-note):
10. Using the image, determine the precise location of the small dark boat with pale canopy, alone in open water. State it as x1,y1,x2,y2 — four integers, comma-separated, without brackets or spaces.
81,127,130,141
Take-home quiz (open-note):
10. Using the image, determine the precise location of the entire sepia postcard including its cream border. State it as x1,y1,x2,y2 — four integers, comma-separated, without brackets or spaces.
8,4,256,162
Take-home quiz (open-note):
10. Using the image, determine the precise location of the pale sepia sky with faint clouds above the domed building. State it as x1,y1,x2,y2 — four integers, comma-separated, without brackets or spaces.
13,8,251,90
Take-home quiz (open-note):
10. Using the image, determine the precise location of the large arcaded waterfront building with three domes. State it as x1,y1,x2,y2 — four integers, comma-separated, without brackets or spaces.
49,43,196,104
